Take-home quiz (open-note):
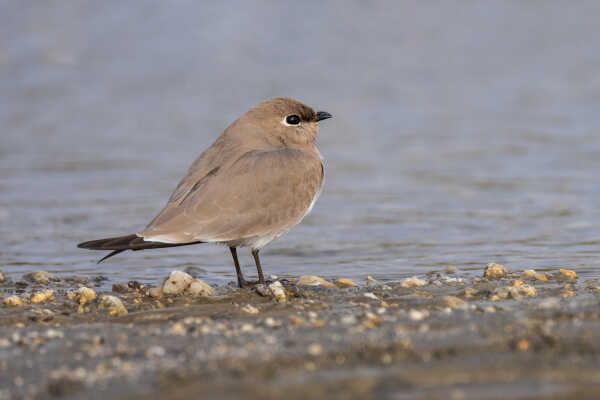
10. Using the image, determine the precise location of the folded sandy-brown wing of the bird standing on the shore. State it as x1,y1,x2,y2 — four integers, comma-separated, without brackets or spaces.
140,148,323,243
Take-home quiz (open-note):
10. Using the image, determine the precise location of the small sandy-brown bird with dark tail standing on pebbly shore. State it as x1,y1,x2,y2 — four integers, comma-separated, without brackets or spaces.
77,97,332,288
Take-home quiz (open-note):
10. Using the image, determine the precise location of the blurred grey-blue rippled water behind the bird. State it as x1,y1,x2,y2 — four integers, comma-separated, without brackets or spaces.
0,0,600,283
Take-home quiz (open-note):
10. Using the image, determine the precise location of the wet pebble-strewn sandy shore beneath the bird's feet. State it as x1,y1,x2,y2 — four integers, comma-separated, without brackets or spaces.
0,266,600,399
